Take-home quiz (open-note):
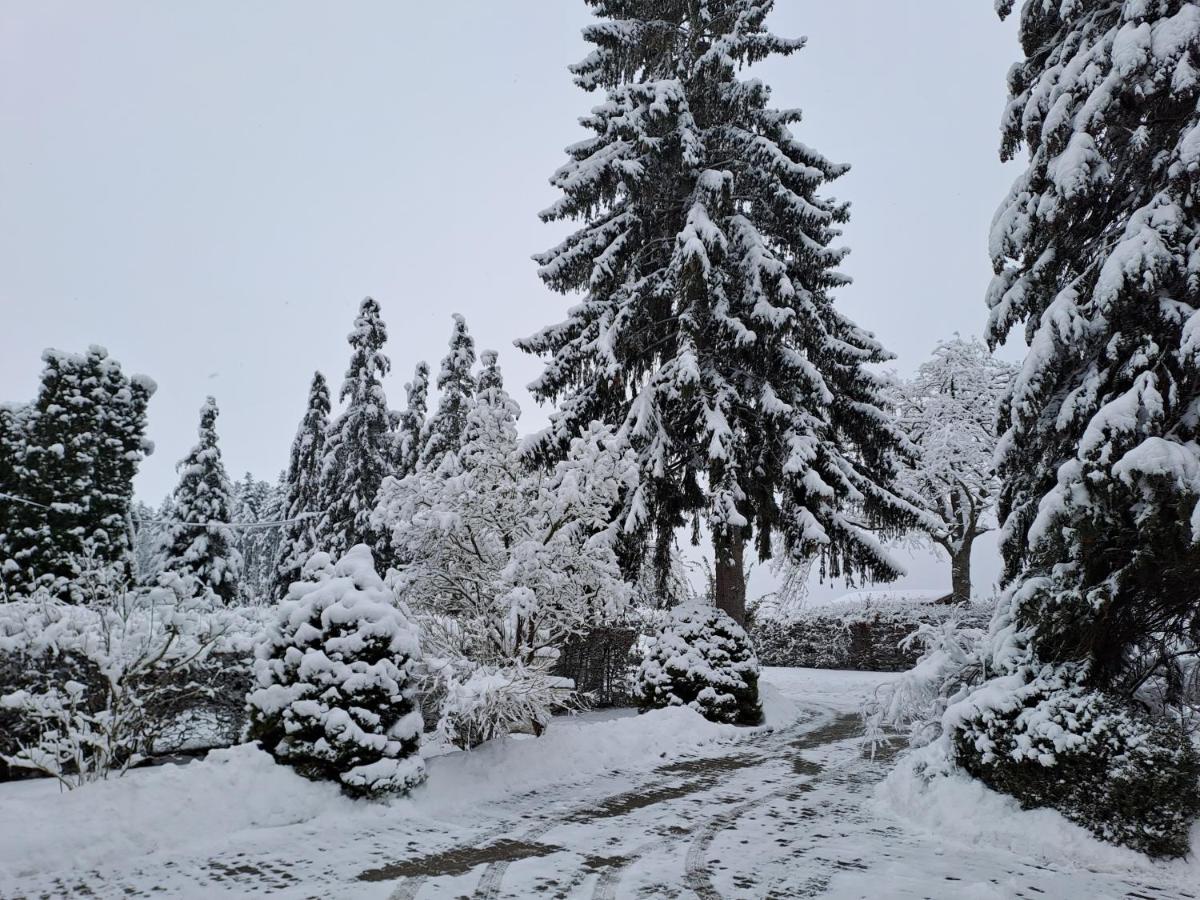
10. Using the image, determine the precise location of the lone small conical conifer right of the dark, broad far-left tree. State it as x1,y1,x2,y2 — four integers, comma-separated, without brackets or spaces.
163,397,242,604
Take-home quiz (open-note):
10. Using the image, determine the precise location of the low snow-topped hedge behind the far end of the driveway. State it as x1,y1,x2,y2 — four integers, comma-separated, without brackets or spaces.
750,594,990,672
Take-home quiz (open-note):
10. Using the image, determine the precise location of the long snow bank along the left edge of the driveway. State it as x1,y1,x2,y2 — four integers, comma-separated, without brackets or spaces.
0,685,797,893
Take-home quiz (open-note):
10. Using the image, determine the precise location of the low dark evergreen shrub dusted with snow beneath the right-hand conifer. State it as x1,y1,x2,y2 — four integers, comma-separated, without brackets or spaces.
947,680,1200,857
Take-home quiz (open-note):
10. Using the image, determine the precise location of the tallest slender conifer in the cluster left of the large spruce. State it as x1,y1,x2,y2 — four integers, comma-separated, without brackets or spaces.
317,296,392,557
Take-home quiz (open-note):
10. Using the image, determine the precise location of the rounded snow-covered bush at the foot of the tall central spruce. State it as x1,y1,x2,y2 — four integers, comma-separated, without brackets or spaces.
634,604,762,725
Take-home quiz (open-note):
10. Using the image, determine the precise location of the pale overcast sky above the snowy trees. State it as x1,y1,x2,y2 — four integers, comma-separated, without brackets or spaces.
0,0,1018,600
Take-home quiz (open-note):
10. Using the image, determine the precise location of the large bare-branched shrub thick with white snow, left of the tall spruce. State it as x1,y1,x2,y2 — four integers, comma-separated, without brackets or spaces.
372,352,636,746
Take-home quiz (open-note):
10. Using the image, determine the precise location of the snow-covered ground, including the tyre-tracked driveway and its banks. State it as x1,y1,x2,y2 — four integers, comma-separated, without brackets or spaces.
0,670,1200,900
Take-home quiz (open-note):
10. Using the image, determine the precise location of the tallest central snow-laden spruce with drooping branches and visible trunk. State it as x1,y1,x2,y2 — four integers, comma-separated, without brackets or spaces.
517,0,919,622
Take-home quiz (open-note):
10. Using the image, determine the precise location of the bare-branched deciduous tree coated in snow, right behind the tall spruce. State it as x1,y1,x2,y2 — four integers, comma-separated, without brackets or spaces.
898,337,1015,602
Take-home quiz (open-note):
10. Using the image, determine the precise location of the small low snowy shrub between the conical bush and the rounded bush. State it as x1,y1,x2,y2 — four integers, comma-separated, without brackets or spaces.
438,665,575,750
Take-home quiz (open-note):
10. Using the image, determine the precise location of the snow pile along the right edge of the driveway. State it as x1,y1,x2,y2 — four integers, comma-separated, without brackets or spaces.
876,750,1200,883
